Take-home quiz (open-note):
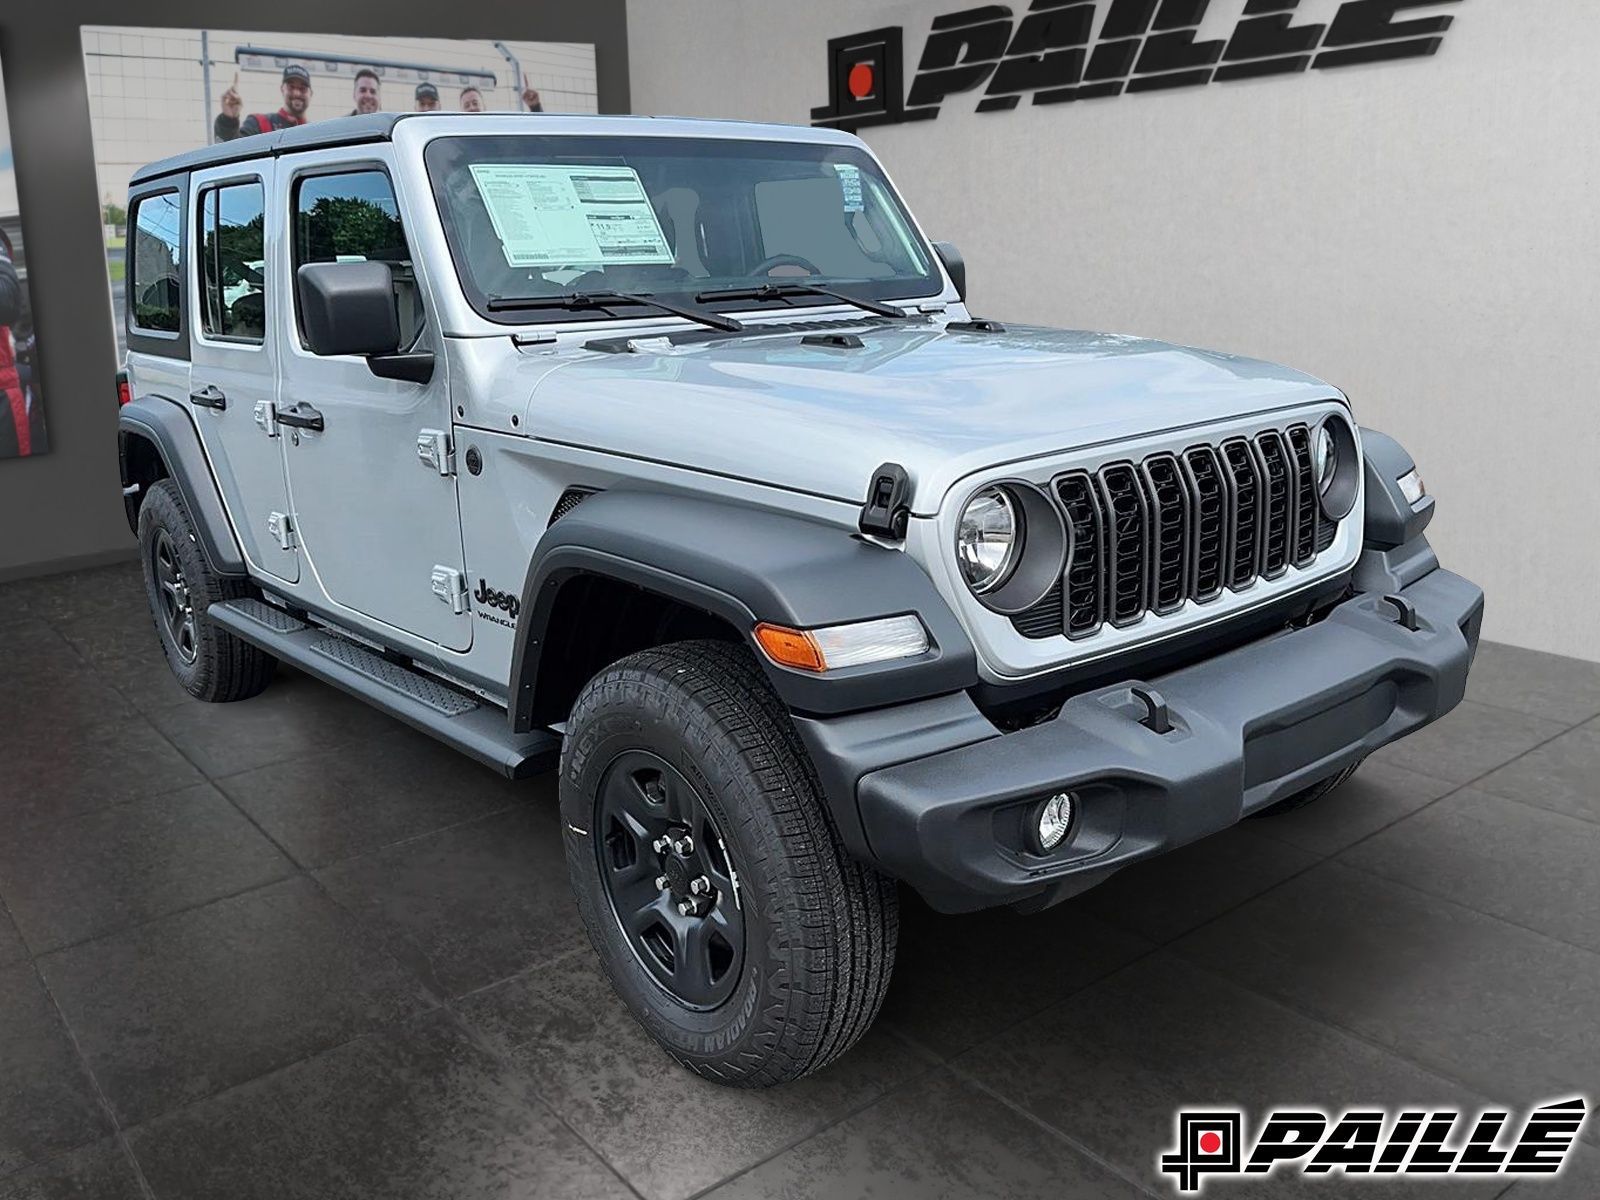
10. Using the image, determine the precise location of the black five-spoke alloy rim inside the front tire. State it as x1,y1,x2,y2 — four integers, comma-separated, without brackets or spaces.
594,750,744,1011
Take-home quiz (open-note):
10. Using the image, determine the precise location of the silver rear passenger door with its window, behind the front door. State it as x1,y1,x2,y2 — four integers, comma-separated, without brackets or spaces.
187,163,299,582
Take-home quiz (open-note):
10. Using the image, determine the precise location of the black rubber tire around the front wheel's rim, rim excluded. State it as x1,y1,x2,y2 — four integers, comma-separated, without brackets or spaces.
560,642,899,1088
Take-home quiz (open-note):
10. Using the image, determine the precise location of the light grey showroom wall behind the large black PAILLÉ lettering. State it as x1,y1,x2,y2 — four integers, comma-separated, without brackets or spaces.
629,0,1600,659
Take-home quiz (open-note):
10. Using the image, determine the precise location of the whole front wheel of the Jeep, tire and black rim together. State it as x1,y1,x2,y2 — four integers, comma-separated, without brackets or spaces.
560,642,898,1088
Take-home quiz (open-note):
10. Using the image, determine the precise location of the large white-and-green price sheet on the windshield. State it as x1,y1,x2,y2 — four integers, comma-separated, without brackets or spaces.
472,163,672,267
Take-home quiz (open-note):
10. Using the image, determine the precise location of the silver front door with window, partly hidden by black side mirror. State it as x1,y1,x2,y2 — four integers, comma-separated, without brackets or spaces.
278,160,472,650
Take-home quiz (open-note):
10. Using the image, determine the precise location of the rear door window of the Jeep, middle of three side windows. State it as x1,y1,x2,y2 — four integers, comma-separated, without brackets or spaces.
200,182,267,344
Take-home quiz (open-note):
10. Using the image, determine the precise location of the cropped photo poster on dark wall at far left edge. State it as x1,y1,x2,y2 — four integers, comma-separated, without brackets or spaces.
0,55,50,459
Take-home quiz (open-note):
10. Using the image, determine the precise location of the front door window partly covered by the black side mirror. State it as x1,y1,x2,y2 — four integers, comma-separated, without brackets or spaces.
293,170,422,346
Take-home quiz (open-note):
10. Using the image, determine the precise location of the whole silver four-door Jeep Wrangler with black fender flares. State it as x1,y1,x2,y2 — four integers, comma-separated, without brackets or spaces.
120,114,1483,1086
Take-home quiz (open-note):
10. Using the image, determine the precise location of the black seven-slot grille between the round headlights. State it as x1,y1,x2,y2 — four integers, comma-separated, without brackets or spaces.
1011,426,1338,638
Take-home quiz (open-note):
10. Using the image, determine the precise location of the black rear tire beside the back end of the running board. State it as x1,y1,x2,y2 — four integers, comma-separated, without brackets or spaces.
139,478,277,704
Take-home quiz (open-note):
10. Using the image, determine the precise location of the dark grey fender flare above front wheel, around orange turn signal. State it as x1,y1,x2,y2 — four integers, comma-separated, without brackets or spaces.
510,491,978,731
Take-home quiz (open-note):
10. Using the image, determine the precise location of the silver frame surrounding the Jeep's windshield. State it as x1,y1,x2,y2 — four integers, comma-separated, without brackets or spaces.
421,130,947,328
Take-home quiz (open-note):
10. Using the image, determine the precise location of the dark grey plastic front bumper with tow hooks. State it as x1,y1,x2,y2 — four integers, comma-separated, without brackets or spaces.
844,570,1483,910
